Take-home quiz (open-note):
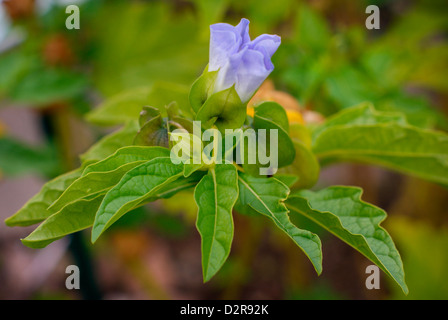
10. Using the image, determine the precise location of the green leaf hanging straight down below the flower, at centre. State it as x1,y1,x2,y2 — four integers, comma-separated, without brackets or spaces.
194,164,238,282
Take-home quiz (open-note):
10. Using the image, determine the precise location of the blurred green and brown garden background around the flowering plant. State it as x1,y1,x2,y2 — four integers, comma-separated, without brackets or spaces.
0,0,448,299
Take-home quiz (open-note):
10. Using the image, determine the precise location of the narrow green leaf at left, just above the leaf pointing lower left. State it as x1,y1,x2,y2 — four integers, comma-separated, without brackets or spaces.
49,147,170,211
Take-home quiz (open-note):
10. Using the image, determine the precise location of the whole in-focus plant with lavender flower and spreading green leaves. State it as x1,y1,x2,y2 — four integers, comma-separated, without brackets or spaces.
6,19,448,293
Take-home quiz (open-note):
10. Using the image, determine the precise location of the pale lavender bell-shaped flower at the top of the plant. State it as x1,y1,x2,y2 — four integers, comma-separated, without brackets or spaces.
208,19,281,102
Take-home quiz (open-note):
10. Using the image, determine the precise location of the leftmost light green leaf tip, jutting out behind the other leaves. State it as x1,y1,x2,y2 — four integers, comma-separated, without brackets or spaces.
5,169,81,227
